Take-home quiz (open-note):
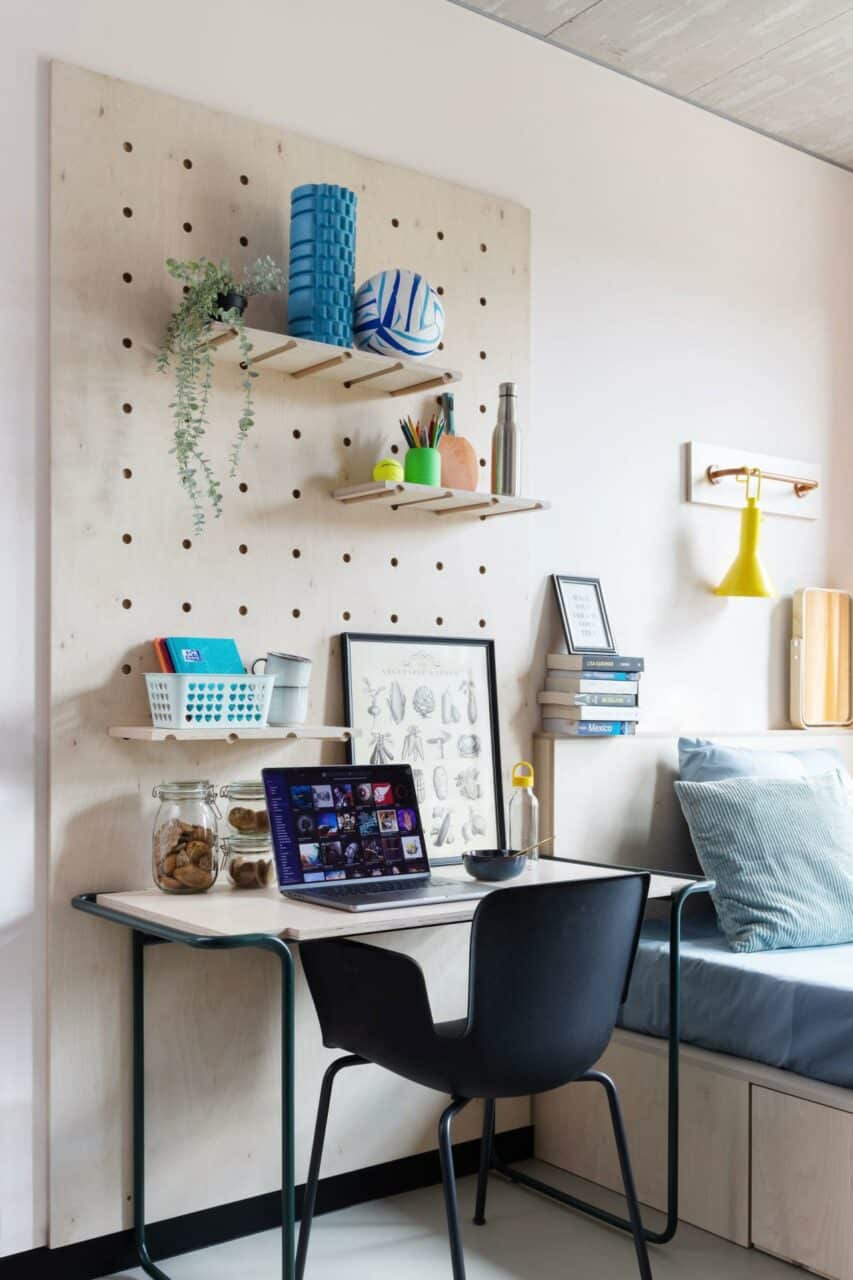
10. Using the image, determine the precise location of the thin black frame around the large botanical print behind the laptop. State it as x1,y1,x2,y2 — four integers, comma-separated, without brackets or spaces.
339,631,506,867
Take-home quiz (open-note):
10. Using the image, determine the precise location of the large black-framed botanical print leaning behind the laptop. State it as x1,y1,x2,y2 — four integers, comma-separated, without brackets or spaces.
341,632,506,861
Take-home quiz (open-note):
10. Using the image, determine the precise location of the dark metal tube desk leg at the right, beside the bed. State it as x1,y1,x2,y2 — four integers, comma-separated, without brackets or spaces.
484,882,708,1244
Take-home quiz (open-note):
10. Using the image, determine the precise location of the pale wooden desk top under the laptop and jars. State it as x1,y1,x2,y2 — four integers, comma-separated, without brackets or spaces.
97,858,690,942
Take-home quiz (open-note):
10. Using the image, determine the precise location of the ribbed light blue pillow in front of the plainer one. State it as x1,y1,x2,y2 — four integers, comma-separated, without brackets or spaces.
675,771,853,951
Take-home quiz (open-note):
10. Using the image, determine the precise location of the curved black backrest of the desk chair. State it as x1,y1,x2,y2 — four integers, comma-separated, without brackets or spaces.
467,874,649,1096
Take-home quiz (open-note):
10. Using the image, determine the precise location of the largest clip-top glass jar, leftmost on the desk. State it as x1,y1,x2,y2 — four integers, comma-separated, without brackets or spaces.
152,782,219,893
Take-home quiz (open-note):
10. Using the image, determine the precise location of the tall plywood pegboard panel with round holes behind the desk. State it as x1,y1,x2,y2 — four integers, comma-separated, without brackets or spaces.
50,64,534,1245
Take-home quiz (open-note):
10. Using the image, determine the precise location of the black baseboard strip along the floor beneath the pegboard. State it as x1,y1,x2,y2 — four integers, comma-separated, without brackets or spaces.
0,1125,533,1280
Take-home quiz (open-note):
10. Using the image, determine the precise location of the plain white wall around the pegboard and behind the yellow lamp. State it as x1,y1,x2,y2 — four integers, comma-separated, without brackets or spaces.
0,0,853,1254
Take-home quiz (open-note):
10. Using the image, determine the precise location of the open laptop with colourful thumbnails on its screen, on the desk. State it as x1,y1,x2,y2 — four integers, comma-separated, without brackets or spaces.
263,764,491,911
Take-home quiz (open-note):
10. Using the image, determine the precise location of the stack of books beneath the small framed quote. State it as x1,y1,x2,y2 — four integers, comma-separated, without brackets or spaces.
538,653,646,737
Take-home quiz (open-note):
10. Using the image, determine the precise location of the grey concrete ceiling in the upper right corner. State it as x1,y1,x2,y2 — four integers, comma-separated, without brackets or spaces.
456,0,853,169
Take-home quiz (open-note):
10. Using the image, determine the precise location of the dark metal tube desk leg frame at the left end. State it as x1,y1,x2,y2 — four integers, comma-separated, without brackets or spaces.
133,929,296,1280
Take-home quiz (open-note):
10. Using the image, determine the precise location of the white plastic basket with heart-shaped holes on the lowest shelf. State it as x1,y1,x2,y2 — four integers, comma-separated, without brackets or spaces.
145,675,275,728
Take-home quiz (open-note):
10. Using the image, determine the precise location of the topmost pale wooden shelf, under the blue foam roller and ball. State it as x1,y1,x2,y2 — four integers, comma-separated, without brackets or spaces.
206,323,462,398
